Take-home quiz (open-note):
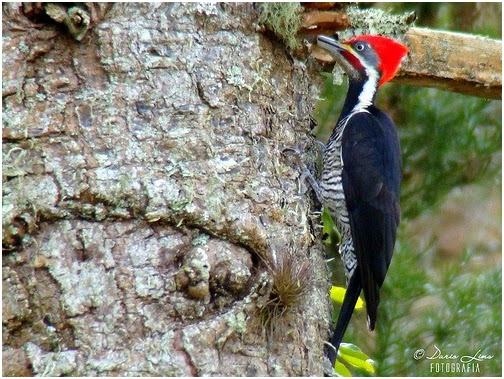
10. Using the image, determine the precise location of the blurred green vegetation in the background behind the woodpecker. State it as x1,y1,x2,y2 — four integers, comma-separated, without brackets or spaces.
314,2,502,376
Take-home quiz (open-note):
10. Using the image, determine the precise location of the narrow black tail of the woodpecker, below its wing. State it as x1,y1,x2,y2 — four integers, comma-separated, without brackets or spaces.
326,270,362,367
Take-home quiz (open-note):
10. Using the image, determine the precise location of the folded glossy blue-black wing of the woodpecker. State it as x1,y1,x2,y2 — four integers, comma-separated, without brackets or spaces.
342,109,401,330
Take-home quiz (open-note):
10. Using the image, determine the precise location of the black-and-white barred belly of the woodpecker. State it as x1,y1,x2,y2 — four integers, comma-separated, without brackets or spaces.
320,120,357,282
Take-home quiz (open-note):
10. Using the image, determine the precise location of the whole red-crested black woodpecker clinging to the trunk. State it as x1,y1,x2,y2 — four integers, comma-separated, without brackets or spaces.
305,35,408,367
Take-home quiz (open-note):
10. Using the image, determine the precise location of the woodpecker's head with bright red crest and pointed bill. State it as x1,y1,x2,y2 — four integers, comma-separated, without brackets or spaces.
317,35,408,86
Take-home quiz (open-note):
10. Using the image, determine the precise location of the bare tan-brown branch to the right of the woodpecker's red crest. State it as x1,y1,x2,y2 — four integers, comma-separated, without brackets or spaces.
396,28,502,100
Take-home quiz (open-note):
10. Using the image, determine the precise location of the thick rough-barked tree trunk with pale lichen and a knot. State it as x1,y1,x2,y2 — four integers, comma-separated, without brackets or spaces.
2,3,330,376
